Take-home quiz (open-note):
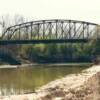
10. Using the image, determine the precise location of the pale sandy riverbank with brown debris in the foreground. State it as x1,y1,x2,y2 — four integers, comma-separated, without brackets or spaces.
0,65,100,100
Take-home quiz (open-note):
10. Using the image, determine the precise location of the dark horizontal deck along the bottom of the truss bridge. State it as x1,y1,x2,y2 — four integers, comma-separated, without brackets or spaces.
0,39,88,45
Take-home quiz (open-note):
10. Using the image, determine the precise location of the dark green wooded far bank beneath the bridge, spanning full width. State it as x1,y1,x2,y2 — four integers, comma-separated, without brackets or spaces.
0,40,100,64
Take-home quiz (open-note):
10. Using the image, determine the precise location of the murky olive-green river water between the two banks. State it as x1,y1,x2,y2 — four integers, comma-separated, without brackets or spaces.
0,66,88,95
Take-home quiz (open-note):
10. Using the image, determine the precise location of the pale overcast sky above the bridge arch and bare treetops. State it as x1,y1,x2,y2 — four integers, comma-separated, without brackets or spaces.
0,0,100,24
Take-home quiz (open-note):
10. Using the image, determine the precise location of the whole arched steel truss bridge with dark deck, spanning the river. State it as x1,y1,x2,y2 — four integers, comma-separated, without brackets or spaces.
0,19,100,45
